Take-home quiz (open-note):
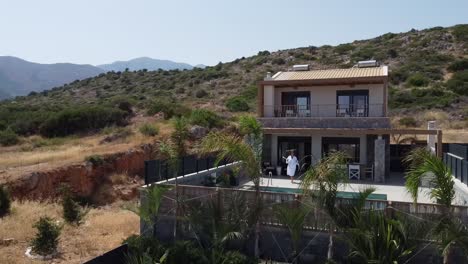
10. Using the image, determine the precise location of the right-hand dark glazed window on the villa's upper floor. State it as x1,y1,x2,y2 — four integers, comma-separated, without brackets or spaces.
336,90,369,117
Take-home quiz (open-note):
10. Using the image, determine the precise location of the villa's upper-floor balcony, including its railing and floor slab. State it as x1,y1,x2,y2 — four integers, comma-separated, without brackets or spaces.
259,104,390,128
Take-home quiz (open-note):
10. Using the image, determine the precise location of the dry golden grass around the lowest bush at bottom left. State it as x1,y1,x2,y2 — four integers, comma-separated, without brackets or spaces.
0,202,139,263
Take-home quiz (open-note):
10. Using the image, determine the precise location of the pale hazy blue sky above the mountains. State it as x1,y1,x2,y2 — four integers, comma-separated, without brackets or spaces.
0,0,468,65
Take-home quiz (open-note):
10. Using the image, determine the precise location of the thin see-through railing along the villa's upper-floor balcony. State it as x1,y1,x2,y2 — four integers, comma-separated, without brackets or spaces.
264,104,384,117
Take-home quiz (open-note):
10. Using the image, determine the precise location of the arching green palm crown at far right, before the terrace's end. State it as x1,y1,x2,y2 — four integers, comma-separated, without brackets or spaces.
405,148,455,207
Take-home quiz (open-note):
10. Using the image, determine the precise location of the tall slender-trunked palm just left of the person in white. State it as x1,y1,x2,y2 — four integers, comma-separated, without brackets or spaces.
200,116,262,257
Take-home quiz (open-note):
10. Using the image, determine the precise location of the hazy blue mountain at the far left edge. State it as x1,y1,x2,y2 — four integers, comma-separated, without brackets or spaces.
0,56,103,99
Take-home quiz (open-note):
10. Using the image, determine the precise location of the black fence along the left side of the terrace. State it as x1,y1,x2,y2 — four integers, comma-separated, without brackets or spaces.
145,155,229,184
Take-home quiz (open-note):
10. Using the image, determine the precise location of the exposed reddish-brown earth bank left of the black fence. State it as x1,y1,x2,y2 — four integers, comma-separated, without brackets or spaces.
8,144,154,200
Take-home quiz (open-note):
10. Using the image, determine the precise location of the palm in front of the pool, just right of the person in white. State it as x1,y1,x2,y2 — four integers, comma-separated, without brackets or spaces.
301,152,347,260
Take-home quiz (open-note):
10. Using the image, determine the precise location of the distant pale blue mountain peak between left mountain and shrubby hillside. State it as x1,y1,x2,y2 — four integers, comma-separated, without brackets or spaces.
97,57,193,72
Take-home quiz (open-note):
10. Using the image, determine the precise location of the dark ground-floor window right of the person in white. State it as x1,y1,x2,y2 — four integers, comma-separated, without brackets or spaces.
322,137,361,163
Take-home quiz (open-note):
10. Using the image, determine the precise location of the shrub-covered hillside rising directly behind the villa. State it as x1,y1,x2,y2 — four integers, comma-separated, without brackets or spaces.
0,25,468,140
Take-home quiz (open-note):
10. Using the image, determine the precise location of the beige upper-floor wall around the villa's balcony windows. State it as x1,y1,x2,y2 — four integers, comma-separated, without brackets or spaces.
264,84,384,117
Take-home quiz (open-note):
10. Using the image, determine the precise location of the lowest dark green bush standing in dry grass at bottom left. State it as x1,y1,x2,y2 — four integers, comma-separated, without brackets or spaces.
31,217,62,256
